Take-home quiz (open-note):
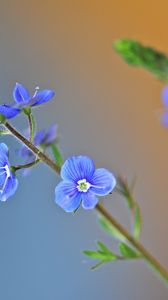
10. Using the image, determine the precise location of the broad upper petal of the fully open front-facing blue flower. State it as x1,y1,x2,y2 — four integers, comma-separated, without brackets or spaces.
61,155,95,183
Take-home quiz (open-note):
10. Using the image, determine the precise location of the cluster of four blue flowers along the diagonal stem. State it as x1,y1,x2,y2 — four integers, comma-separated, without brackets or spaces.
0,83,116,212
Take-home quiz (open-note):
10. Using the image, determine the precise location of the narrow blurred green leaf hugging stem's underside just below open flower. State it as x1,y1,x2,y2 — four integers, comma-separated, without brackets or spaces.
98,216,126,242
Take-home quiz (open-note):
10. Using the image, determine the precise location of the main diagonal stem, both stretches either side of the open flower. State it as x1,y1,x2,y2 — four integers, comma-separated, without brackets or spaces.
4,121,168,285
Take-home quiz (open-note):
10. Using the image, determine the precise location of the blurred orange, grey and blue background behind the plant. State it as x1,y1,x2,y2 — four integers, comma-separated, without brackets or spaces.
0,0,168,300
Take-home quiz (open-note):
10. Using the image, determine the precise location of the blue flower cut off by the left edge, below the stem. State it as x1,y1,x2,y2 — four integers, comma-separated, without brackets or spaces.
0,143,18,201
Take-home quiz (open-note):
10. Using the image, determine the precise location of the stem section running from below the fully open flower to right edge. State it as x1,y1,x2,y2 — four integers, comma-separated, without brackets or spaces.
96,204,168,285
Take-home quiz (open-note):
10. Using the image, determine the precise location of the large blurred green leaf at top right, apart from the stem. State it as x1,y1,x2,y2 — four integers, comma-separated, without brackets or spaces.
114,39,168,81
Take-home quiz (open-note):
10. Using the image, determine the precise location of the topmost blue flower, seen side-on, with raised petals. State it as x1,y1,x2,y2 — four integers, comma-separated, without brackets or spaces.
0,83,55,119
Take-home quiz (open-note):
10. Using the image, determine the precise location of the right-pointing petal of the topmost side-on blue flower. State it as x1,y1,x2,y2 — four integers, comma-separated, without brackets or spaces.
29,90,55,106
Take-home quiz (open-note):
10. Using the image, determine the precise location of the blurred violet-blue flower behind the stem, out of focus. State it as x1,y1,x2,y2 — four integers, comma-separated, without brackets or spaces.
17,124,58,175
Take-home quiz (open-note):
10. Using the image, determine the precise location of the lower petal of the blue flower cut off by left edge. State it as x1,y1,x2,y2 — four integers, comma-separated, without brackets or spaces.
0,173,18,201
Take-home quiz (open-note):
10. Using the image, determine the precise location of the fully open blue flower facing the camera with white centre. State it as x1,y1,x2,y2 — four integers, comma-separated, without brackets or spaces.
55,156,116,212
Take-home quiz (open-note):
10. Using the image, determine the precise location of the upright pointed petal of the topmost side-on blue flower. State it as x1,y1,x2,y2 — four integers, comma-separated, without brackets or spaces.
13,83,30,104
